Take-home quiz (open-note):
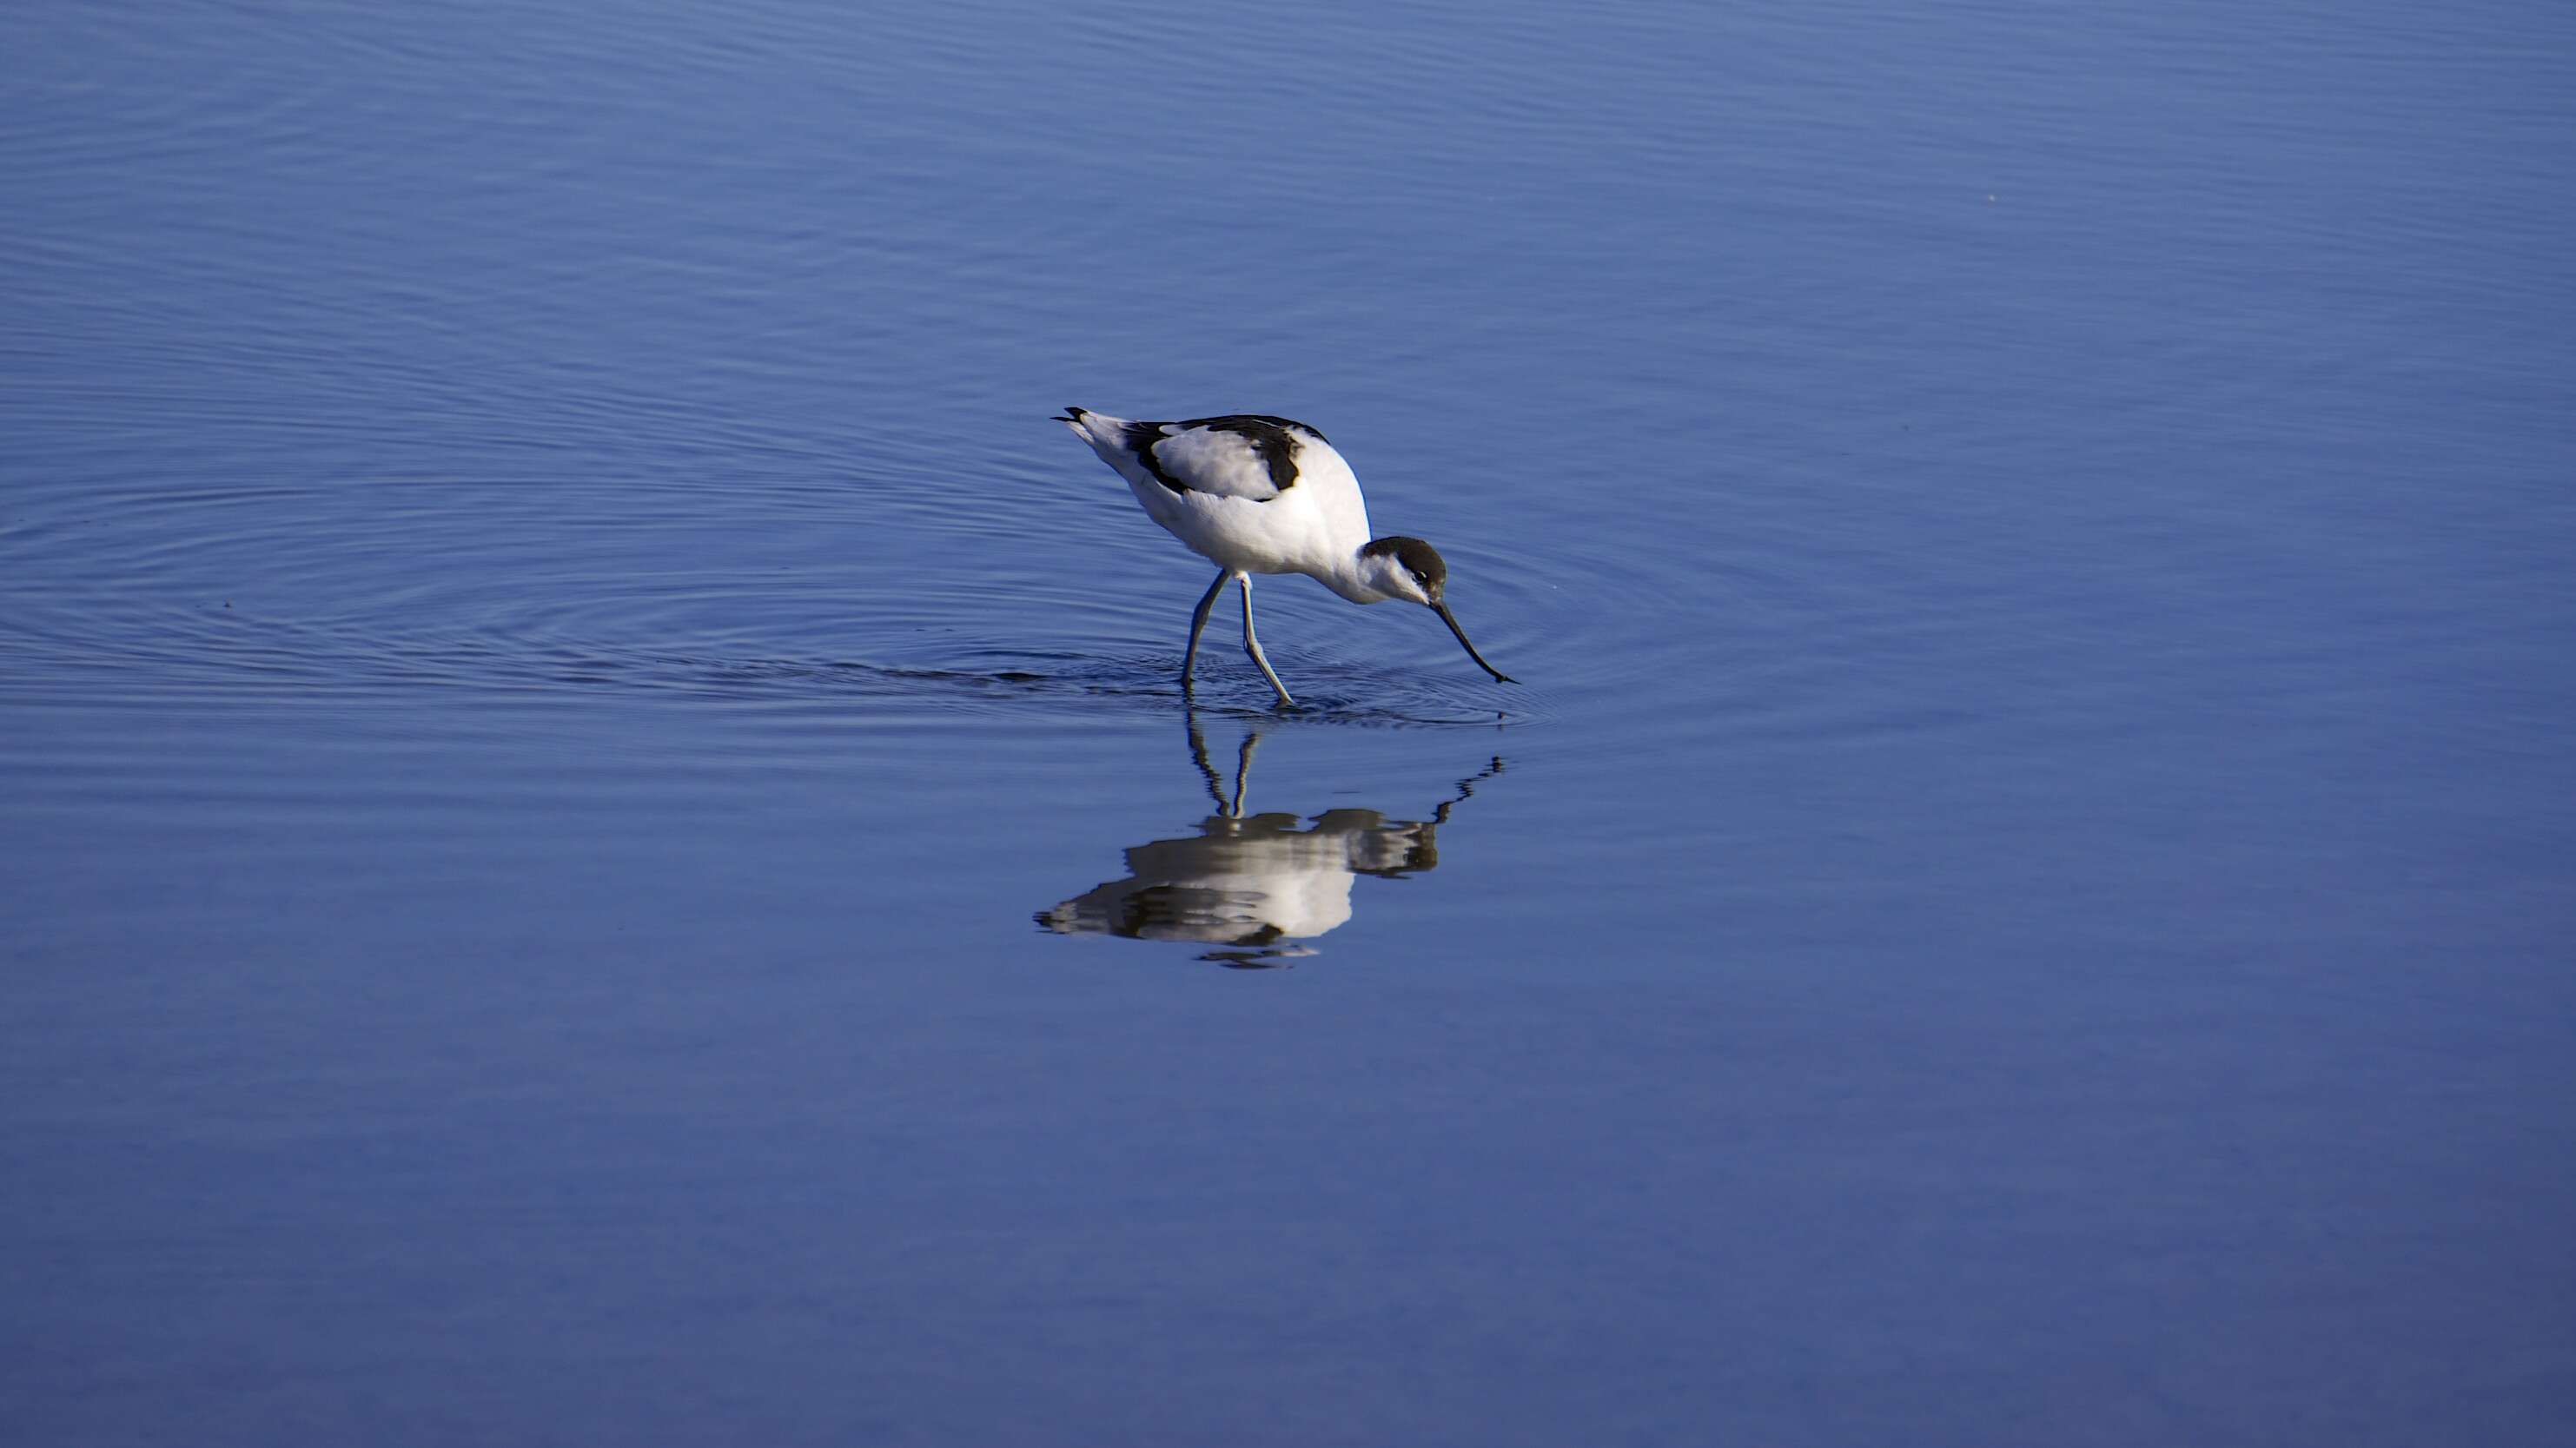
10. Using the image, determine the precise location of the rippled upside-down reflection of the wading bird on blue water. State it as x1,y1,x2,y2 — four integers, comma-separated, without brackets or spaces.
1038,711,1502,971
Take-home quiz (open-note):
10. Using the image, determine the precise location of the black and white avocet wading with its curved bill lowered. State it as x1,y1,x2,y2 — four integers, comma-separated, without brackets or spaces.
1056,407,1512,704
